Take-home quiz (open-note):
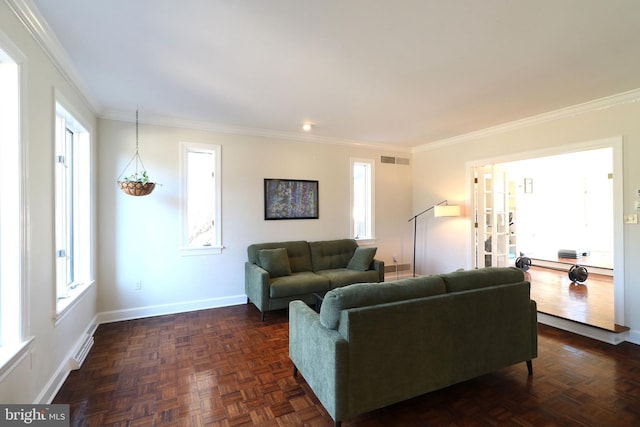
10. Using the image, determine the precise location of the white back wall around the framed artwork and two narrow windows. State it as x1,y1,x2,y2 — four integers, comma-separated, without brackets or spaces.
98,118,412,321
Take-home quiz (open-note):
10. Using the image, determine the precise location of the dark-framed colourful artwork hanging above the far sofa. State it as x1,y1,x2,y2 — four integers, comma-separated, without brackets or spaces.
264,178,320,220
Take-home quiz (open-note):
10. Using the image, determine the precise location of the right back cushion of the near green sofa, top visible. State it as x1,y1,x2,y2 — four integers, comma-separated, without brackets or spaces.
440,267,524,292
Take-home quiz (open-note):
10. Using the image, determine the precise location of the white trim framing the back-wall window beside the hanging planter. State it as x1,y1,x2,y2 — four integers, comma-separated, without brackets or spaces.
178,141,224,256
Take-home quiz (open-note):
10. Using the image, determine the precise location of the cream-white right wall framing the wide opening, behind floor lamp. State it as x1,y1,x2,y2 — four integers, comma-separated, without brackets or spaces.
413,98,640,343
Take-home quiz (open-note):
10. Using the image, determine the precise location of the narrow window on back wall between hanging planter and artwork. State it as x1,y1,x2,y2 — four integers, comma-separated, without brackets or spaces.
181,142,222,254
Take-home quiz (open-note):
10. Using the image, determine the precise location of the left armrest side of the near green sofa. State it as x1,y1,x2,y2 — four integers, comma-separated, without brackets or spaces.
289,301,349,421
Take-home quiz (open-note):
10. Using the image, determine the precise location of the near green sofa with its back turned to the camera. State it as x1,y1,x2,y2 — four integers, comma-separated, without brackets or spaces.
289,267,538,426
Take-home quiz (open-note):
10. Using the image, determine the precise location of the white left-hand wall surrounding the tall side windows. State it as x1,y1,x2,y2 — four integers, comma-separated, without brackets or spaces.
0,2,97,403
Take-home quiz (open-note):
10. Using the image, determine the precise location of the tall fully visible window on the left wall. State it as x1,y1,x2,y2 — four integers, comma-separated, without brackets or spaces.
54,104,92,312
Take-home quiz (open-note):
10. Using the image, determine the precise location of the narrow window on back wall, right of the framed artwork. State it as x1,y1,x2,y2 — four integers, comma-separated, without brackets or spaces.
351,159,375,240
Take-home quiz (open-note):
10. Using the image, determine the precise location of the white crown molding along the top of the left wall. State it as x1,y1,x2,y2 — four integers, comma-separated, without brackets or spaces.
5,0,100,114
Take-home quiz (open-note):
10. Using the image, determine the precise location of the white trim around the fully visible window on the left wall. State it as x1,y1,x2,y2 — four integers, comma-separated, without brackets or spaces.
52,96,95,318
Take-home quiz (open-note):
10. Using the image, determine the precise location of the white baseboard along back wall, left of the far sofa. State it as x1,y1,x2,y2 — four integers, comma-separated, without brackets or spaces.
97,294,247,324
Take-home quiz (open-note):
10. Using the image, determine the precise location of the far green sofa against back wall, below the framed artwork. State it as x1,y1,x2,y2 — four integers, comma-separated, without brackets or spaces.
244,239,384,320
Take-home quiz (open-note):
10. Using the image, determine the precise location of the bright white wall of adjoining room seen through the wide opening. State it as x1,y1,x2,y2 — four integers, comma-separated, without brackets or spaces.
502,148,613,260
